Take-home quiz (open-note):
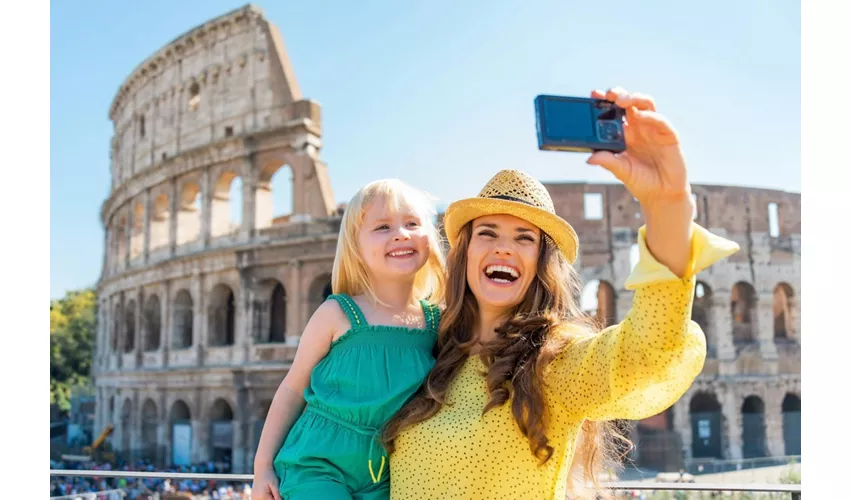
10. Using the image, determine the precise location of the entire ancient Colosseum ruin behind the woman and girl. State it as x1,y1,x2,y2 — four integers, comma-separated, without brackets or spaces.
93,5,800,472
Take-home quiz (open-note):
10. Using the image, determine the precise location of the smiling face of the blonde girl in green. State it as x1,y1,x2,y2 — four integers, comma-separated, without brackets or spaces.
357,197,430,280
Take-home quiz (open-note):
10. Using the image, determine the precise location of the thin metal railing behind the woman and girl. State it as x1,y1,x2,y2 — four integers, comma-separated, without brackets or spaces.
50,469,802,500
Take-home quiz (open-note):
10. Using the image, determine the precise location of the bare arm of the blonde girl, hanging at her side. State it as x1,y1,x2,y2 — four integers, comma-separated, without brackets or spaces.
254,300,348,474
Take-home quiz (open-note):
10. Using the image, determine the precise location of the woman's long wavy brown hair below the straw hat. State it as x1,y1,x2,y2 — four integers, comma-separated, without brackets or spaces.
383,222,630,498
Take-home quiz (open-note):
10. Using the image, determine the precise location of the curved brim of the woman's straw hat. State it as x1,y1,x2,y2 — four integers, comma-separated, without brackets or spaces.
443,198,578,264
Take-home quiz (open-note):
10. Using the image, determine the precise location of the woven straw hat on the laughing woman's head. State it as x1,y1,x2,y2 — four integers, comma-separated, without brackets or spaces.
443,170,578,264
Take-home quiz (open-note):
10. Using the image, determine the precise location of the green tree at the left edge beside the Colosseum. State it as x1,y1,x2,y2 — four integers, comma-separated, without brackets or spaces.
50,289,97,411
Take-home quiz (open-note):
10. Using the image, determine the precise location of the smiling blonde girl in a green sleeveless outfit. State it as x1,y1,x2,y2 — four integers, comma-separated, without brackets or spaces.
253,180,445,500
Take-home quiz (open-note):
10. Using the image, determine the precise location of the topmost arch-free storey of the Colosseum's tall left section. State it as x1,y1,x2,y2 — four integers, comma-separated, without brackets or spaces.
109,5,304,188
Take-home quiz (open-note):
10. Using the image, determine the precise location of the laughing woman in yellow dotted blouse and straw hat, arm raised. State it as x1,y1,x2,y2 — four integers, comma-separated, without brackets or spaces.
384,89,738,500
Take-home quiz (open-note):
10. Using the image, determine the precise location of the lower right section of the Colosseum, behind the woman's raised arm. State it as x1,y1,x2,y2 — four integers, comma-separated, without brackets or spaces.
547,183,801,469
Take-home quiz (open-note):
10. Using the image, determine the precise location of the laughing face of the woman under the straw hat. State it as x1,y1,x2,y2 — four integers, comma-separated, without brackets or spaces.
466,215,540,314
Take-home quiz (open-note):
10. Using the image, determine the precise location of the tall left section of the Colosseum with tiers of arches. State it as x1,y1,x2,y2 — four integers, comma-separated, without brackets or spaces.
94,6,339,471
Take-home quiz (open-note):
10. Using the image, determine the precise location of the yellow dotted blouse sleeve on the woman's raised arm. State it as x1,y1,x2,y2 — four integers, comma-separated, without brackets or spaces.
545,224,739,420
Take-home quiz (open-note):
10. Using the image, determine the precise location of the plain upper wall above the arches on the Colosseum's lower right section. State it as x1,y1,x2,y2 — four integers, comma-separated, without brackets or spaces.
545,183,800,293
